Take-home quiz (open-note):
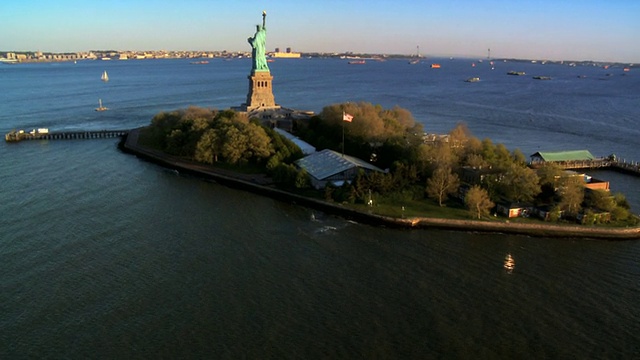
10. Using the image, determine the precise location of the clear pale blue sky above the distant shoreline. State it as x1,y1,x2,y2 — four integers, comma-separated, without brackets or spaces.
0,0,640,63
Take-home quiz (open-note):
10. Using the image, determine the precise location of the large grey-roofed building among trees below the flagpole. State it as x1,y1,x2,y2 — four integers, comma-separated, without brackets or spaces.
295,149,384,189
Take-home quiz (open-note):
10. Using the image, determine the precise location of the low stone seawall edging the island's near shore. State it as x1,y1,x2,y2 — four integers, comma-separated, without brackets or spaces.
119,129,640,240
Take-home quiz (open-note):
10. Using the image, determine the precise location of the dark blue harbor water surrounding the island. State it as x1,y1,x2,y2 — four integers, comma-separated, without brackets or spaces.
0,59,640,359
